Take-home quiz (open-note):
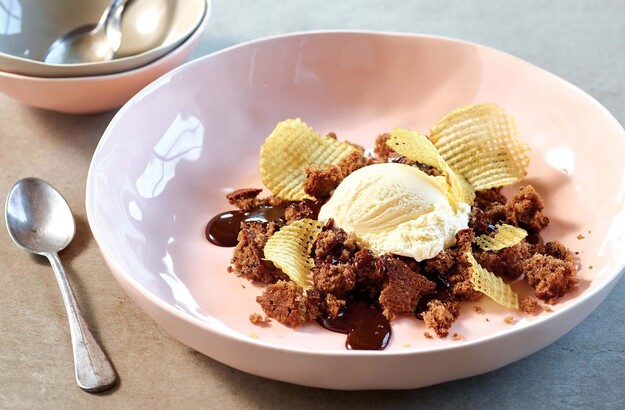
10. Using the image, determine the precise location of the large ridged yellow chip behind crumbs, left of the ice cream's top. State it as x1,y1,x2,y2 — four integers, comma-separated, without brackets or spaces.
260,118,356,201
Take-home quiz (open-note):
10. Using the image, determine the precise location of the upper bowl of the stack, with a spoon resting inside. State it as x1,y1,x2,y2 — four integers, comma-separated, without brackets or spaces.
0,0,210,77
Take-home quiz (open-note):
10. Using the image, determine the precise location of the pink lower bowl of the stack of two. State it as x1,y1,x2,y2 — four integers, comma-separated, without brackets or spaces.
0,5,209,114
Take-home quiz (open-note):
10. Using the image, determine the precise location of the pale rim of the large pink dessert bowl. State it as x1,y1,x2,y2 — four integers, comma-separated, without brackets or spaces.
85,29,625,358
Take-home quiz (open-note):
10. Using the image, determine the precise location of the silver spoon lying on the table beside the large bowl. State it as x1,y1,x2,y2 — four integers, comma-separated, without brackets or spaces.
6,178,117,392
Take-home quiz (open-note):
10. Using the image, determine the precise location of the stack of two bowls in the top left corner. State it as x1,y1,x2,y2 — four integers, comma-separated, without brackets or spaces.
0,0,210,114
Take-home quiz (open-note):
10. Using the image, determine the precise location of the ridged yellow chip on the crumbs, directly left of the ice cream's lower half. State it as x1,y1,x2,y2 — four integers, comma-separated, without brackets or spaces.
264,219,323,290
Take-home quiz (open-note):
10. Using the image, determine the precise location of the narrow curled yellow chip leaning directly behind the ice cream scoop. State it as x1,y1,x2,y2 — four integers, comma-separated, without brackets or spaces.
386,128,475,206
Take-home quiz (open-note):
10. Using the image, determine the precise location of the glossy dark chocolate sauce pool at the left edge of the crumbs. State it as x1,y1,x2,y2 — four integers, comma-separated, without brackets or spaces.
206,206,284,247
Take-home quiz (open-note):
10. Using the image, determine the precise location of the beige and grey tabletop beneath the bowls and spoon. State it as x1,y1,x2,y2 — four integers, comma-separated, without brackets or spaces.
0,0,625,409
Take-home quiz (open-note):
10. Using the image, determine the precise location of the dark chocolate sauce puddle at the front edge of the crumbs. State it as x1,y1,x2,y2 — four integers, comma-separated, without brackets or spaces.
318,295,391,350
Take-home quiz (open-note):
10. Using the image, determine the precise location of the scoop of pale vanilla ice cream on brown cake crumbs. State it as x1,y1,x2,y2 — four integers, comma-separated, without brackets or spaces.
319,163,470,261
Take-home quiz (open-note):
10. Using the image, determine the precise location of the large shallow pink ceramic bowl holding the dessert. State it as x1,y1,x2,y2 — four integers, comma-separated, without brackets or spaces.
87,32,625,389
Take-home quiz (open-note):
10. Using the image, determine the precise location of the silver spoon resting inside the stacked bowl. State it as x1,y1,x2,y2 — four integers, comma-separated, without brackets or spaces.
42,0,131,64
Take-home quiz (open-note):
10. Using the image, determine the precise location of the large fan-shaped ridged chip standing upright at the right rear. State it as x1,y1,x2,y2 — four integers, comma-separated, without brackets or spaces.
430,104,530,191
